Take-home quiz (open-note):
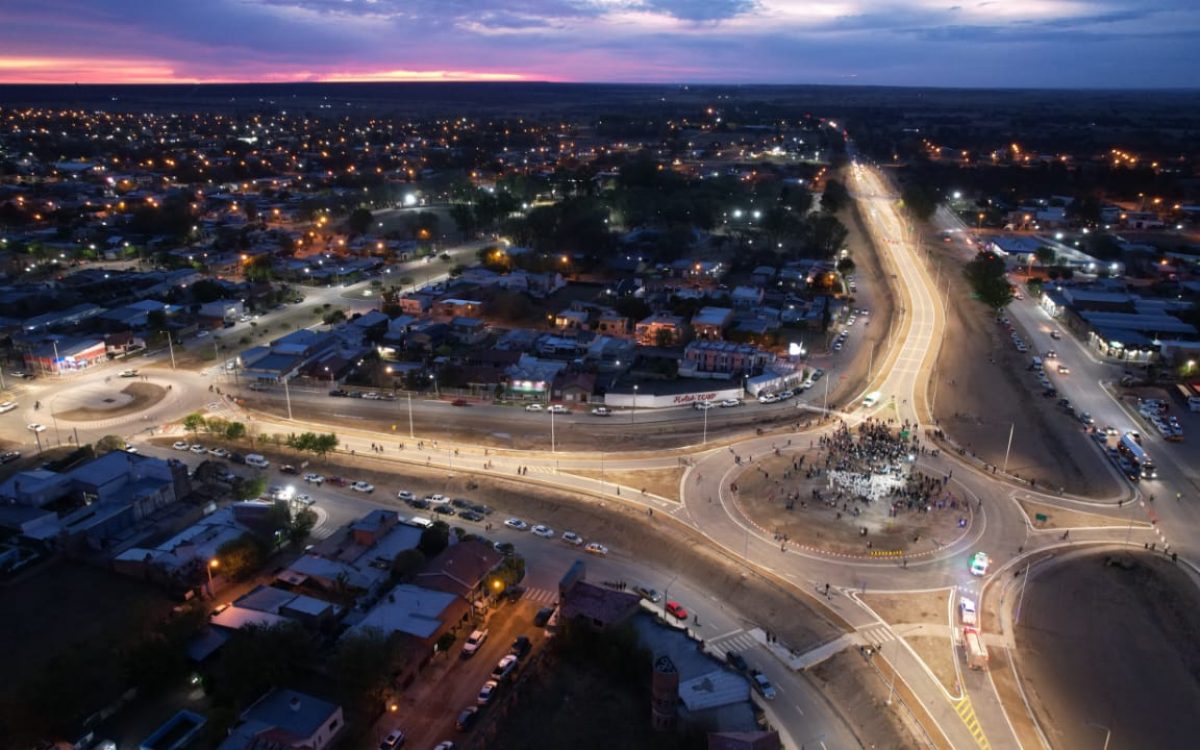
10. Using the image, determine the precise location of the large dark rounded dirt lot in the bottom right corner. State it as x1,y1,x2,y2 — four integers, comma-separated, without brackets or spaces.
1015,553,1200,750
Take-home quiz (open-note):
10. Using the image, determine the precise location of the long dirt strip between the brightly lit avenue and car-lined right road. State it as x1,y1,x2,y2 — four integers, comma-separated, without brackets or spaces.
926,241,1111,494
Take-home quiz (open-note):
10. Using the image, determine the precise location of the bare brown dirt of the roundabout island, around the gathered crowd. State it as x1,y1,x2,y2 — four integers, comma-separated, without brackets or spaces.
736,450,971,554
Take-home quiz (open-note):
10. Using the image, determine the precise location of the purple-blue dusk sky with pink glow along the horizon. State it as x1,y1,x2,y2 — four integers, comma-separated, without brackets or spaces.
0,0,1200,89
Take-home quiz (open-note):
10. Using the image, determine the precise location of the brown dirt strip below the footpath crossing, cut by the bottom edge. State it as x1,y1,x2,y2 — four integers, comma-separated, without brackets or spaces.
805,649,925,748
